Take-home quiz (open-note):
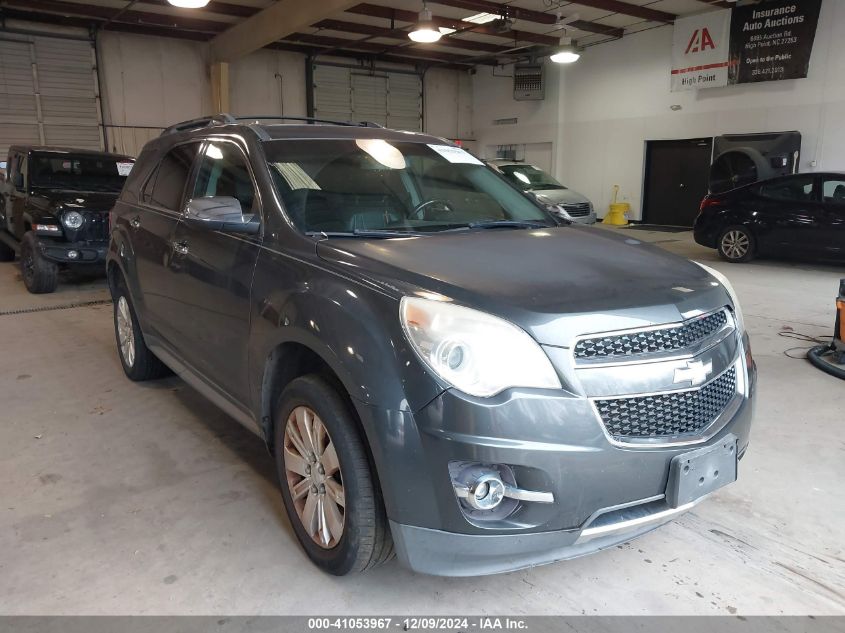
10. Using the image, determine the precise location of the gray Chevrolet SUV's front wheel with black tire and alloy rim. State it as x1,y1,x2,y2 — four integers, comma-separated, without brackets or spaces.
273,375,393,576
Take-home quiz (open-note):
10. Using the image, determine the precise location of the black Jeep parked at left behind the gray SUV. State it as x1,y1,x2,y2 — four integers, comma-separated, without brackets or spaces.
0,145,134,293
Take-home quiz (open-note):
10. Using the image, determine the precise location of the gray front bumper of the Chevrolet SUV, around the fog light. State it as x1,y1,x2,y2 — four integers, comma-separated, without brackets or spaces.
352,346,756,576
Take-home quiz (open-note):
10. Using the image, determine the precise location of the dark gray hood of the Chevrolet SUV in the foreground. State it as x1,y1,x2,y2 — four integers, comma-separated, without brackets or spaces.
317,226,730,347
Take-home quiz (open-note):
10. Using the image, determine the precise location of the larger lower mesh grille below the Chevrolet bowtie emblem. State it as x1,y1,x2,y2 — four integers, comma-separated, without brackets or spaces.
595,367,736,441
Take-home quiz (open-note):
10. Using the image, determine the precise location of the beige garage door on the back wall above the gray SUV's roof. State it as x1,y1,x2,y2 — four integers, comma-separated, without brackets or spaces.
313,64,422,132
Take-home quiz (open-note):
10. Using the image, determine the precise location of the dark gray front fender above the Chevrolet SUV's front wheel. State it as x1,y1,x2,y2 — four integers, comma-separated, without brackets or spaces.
249,244,444,411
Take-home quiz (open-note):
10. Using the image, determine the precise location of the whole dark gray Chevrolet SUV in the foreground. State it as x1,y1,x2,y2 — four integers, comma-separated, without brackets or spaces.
107,115,755,575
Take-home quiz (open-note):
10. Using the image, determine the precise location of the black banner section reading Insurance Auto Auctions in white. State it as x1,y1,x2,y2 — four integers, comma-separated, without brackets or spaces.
728,0,822,84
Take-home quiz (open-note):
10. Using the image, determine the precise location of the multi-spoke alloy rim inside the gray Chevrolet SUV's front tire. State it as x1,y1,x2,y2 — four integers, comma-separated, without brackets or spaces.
283,406,346,549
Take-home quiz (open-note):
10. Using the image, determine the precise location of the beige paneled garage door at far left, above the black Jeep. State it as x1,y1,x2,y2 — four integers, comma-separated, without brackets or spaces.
0,36,103,157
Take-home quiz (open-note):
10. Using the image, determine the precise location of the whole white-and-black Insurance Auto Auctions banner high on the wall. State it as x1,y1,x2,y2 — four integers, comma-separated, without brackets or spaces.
672,0,822,91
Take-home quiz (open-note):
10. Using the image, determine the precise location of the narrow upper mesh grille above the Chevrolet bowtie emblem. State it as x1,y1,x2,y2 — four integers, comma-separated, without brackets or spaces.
575,310,728,359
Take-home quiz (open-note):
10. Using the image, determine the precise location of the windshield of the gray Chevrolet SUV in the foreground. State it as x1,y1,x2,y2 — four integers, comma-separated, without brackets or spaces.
265,139,554,234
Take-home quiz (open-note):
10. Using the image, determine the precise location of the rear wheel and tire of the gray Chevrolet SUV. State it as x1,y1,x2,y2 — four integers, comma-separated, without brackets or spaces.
113,282,172,382
